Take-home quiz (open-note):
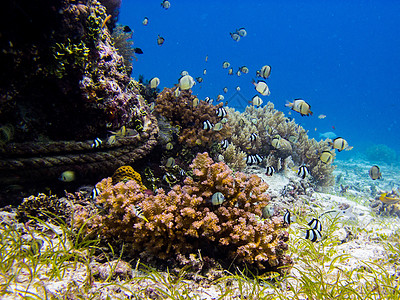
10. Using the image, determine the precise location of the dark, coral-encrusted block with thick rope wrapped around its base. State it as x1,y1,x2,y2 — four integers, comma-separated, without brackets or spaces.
0,0,158,202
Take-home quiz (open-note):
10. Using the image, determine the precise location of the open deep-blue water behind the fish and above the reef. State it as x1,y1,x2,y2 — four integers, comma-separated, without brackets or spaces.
119,0,400,158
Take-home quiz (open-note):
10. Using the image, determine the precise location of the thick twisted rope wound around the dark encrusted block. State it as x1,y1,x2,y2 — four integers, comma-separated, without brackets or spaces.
0,116,159,185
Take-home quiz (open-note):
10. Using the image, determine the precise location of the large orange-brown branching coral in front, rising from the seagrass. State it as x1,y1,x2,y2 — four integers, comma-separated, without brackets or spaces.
74,153,291,273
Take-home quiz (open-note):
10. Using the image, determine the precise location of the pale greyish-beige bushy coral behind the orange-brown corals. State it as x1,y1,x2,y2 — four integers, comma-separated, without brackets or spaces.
227,102,335,186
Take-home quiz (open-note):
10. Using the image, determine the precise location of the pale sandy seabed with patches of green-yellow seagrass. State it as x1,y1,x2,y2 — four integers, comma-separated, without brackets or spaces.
0,160,400,299
